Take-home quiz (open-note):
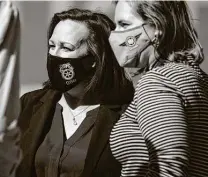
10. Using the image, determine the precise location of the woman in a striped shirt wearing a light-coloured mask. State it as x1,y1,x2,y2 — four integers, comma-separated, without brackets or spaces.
109,0,208,177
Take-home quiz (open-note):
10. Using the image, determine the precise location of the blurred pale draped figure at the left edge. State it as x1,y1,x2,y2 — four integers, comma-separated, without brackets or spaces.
0,2,20,177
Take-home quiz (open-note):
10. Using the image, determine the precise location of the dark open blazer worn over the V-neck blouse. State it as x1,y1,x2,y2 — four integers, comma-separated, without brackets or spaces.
17,89,132,177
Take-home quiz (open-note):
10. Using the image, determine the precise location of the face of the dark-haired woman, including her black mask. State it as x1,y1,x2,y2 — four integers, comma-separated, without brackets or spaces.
47,20,95,92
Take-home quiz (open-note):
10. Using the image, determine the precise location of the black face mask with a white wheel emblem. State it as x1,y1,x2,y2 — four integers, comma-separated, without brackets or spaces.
47,54,95,92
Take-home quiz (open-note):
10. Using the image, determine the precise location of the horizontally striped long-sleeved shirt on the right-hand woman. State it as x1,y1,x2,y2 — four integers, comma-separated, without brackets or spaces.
110,60,208,177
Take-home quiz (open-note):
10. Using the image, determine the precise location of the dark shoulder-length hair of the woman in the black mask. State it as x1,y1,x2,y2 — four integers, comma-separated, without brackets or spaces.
45,8,133,103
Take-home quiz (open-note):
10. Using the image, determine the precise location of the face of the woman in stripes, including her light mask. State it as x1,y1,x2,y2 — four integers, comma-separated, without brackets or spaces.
109,1,155,69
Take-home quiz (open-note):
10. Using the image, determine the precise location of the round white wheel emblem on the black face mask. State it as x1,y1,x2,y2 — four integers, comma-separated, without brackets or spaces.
59,63,75,80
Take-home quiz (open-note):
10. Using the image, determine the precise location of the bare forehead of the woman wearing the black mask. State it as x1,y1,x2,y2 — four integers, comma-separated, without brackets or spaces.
51,20,89,45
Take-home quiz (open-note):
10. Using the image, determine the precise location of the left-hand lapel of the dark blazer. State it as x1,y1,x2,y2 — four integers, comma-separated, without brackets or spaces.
20,90,60,176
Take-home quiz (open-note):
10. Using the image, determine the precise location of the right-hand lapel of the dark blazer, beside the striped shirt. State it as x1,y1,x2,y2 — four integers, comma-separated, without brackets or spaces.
82,106,121,177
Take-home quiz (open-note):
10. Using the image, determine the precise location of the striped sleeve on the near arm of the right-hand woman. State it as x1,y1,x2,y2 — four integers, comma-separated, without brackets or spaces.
136,73,189,177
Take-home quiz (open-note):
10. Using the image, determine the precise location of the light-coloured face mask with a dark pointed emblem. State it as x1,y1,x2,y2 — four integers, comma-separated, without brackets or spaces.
109,24,154,68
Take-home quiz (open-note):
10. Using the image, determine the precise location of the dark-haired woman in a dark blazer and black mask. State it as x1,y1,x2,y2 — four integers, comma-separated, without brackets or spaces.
17,9,134,177
